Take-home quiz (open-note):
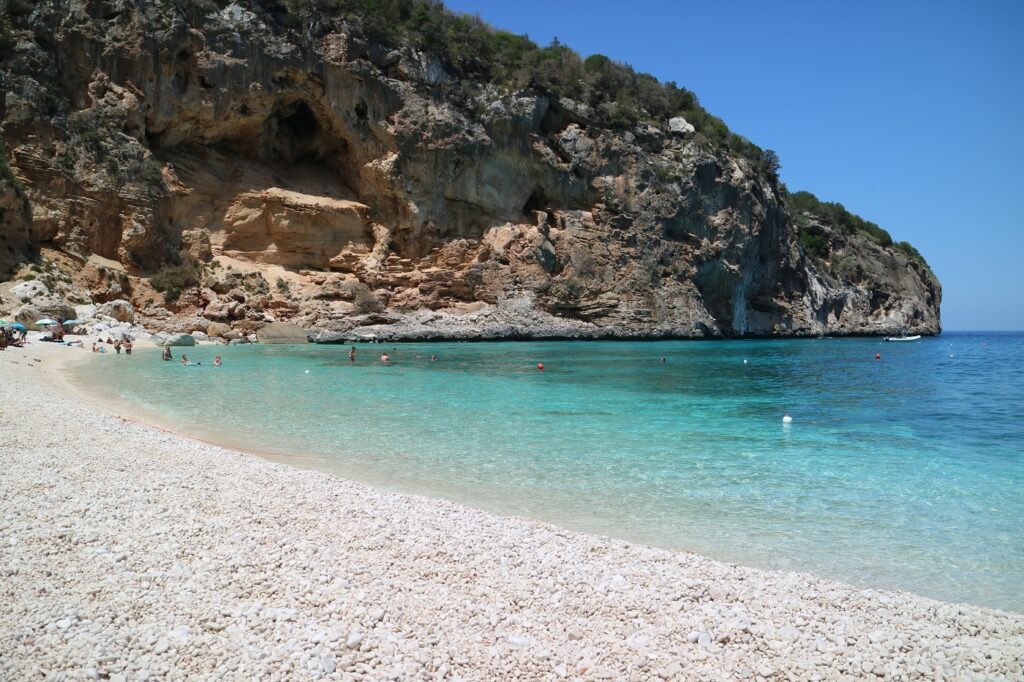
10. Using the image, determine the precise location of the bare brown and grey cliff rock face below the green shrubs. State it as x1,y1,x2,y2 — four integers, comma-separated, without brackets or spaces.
0,0,941,340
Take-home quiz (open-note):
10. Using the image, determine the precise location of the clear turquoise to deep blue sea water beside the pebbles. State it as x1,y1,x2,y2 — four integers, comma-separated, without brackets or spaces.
73,334,1024,610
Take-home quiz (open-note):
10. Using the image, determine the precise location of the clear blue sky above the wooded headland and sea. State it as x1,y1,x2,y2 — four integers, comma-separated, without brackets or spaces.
445,0,1024,330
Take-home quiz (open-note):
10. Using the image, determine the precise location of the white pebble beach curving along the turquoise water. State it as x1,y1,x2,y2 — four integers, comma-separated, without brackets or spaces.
0,343,1024,680
